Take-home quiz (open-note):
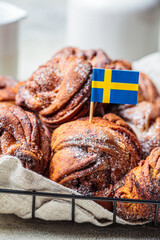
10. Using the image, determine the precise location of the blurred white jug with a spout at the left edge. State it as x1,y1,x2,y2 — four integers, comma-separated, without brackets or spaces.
0,2,26,78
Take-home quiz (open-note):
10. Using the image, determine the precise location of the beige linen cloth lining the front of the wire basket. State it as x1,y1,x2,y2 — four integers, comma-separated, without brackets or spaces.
0,156,131,226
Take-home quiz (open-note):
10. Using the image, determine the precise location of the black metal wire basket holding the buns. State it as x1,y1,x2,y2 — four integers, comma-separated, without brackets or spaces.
0,189,160,227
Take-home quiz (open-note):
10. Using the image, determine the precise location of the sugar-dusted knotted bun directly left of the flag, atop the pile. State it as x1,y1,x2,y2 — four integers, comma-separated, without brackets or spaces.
16,55,92,128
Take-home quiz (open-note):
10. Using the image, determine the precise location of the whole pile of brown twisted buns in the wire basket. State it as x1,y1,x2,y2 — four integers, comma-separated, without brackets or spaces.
0,47,160,221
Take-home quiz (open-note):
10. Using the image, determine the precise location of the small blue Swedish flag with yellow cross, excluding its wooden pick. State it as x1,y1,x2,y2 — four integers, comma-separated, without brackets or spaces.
91,68,139,105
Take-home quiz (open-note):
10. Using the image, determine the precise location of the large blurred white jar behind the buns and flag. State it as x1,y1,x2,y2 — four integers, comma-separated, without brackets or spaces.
66,0,160,61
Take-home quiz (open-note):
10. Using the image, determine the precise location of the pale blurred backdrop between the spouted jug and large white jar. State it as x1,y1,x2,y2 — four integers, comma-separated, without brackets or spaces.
2,0,67,80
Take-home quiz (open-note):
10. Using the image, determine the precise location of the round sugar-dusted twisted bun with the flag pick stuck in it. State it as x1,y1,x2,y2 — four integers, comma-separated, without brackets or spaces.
49,114,142,195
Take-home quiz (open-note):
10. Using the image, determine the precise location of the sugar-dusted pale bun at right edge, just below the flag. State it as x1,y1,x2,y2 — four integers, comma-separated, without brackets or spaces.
112,101,160,158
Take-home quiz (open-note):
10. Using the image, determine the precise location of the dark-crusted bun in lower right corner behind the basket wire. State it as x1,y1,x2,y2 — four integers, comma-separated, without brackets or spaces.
115,147,160,221
